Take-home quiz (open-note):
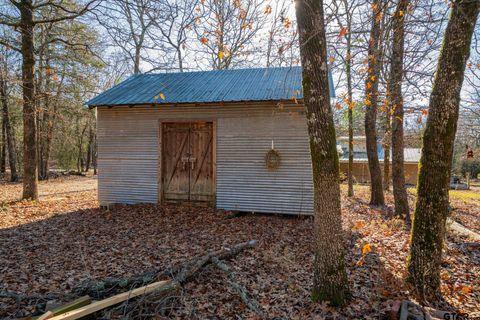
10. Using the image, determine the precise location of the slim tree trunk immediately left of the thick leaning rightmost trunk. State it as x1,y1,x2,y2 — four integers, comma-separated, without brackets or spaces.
389,0,410,221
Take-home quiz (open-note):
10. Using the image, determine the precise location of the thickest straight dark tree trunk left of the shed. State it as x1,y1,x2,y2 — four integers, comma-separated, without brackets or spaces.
19,0,38,200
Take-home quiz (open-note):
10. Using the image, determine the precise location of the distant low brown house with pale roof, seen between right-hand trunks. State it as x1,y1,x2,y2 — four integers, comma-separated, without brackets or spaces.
337,136,421,185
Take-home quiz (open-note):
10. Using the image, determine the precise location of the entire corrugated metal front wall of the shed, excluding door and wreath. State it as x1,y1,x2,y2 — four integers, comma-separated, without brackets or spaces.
98,105,313,214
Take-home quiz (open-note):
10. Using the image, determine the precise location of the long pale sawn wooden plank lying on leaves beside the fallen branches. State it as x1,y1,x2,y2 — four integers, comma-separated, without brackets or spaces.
49,280,171,320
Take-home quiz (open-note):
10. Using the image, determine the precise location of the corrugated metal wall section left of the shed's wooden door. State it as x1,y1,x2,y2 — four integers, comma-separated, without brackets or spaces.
97,109,158,204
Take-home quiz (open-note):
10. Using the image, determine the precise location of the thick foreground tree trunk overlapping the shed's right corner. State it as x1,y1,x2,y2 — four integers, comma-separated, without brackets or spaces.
296,0,349,305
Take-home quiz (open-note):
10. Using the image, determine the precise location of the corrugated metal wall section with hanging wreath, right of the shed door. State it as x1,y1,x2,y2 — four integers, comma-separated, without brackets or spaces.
217,114,313,214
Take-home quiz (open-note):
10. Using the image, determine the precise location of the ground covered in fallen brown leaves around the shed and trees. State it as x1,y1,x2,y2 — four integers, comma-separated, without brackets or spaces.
0,177,480,319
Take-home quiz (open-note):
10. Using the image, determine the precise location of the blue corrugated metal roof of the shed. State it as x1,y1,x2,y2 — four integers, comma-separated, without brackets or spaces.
86,66,335,107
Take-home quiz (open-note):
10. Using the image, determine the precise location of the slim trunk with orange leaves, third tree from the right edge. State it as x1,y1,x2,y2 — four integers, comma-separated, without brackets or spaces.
365,0,385,205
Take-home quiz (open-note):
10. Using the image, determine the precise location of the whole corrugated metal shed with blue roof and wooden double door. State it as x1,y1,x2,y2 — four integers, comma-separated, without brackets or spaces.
87,67,334,214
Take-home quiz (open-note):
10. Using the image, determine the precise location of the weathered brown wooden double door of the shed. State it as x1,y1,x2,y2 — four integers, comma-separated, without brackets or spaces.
161,122,215,203
